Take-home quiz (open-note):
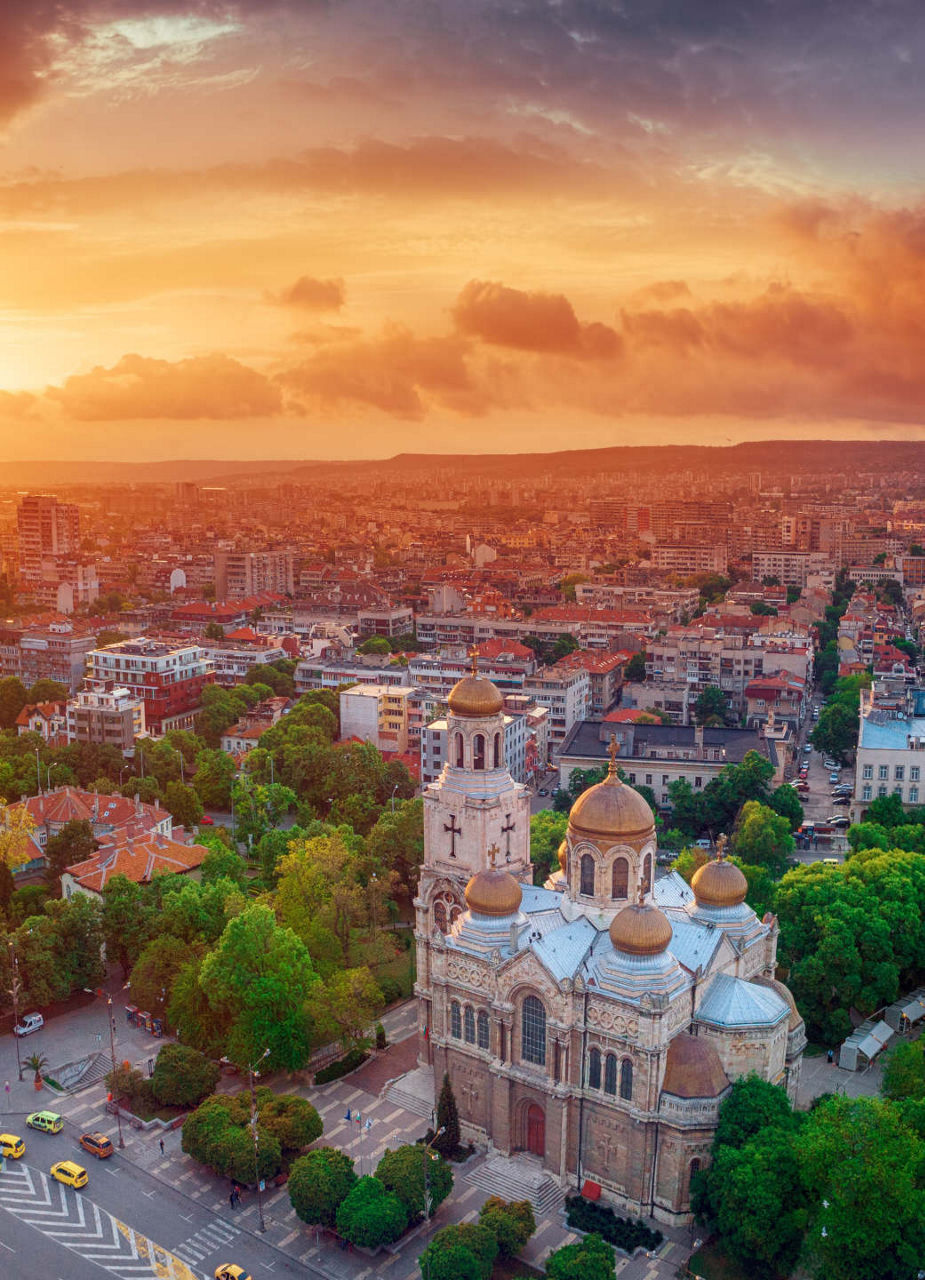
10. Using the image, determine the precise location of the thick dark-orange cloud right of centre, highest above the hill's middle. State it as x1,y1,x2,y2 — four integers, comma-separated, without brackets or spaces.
453,280,621,358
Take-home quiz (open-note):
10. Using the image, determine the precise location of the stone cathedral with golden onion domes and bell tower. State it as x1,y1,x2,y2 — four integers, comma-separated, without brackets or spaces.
415,655,806,1222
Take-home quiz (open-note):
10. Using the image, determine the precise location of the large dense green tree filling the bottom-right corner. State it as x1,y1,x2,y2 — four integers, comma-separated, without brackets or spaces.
800,1094,925,1280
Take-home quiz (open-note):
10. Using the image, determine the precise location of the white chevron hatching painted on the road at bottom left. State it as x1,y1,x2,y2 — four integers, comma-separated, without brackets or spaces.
0,1161,197,1280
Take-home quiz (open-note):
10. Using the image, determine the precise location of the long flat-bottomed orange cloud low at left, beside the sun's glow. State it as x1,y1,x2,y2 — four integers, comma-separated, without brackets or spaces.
46,355,281,422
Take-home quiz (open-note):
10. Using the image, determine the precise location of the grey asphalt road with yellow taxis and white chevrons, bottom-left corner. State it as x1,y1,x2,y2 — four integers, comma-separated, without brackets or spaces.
0,1116,321,1280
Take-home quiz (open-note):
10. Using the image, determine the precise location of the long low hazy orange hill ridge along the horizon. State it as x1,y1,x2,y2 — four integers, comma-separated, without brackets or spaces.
0,439,925,488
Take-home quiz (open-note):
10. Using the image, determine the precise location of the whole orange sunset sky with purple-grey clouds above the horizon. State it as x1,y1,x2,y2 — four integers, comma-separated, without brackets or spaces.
0,0,925,460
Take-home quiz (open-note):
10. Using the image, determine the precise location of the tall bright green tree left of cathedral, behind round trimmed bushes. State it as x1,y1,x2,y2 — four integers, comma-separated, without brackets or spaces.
200,904,319,1071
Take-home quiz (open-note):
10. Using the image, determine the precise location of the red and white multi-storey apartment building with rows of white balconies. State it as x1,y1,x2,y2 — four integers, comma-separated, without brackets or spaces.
87,636,215,737
